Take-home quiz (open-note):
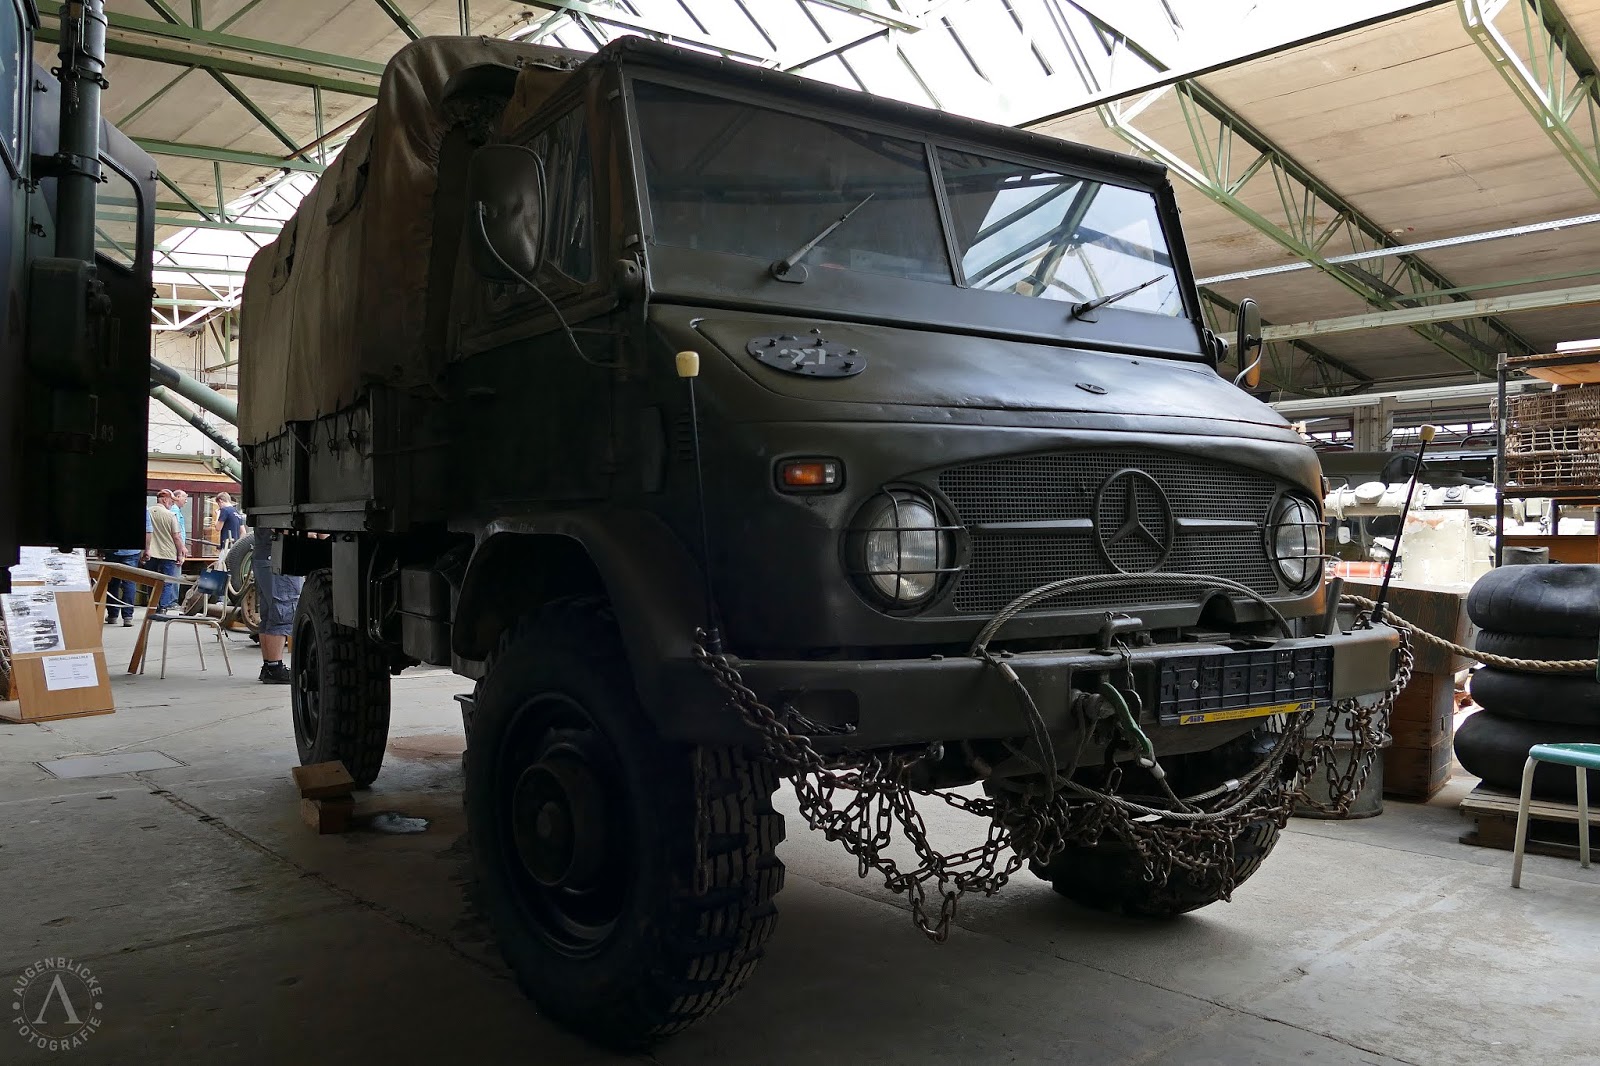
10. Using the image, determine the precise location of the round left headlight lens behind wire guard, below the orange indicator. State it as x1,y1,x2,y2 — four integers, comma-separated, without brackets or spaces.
853,490,955,607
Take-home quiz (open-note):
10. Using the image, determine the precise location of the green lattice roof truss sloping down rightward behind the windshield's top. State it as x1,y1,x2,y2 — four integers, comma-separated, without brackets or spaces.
1090,19,1533,376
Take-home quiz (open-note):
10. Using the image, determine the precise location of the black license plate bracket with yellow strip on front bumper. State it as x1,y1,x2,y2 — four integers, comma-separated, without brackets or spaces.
1157,645,1333,725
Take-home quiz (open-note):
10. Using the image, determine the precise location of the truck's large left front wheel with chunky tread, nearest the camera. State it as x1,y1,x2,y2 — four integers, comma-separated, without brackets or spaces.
466,600,784,1048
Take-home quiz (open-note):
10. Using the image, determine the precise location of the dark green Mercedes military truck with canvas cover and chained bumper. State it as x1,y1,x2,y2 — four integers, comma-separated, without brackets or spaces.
240,38,1397,1045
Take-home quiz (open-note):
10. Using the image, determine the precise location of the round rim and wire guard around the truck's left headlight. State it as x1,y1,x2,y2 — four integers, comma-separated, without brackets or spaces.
842,482,966,615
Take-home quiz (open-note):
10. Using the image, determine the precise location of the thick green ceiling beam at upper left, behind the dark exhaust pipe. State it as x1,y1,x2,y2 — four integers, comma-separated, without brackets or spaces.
38,0,384,96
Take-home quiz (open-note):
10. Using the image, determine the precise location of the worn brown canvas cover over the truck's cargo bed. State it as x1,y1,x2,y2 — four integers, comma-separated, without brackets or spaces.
238,37,584,445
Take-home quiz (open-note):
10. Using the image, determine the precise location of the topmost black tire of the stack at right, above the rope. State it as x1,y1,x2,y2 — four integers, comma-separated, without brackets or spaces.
1467,563,1600,639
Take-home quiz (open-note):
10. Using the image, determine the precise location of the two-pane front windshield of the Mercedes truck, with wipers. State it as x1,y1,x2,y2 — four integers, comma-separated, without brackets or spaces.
635,82,1184,315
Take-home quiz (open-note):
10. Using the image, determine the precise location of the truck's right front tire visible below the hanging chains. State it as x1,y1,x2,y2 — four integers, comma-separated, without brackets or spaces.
1029,820,1278,919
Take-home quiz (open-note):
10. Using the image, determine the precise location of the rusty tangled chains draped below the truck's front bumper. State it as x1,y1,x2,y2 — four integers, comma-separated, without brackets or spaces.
693,621,1413,943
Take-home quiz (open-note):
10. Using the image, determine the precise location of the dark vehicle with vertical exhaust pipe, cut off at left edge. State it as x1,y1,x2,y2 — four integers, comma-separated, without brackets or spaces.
0,0,155,589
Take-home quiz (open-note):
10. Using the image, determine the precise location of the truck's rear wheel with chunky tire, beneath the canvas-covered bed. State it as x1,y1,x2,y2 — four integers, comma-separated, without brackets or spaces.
290,570,389,786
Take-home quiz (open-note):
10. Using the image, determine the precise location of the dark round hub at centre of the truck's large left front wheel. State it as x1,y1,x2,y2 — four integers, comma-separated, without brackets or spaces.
512,751,608,892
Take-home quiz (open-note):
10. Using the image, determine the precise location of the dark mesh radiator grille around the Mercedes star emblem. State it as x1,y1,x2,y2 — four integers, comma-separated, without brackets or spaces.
938,451,1278,611
